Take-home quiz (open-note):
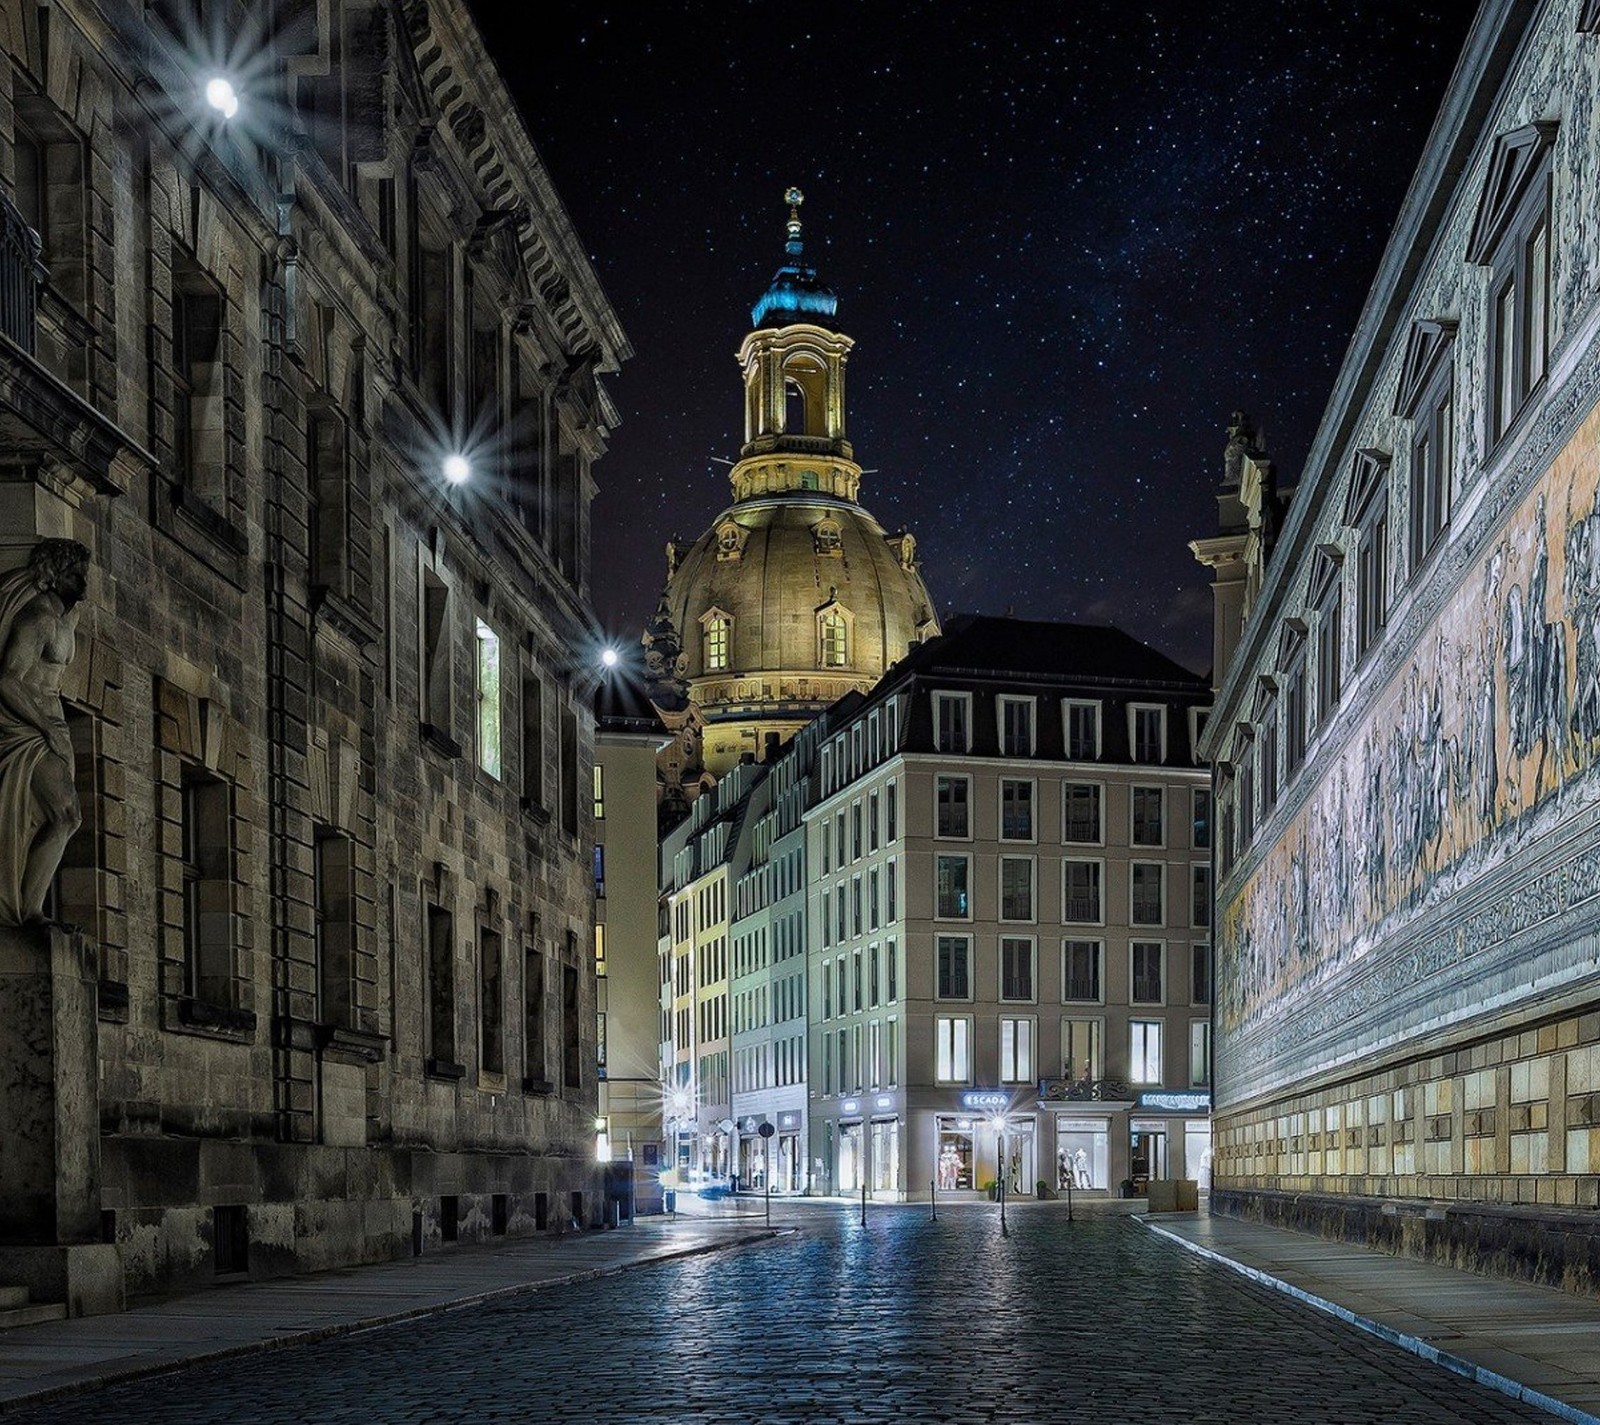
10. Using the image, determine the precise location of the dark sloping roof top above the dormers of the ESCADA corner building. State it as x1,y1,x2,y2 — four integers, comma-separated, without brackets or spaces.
885,614,1211,693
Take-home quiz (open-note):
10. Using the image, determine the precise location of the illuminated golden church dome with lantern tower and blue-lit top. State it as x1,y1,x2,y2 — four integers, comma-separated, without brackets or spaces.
653,189,938,800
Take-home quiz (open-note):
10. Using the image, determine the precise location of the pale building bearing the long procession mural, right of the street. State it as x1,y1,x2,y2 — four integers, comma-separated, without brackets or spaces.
1197,0,1600,1291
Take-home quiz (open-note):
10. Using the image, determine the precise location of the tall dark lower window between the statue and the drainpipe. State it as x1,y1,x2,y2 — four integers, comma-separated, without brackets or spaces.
181,764,235,1006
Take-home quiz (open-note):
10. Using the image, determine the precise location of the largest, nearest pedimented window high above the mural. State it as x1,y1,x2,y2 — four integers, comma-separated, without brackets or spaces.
1467,123,1555,441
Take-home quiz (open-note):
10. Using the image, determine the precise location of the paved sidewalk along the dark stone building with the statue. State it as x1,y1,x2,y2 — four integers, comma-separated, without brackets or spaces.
0,1211,781,1411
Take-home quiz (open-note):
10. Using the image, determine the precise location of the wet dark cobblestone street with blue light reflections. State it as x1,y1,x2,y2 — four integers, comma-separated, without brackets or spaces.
8,1206,1550,1425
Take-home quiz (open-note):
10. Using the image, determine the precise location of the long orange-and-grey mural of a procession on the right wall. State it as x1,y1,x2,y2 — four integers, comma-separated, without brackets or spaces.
1216,398,1600,1035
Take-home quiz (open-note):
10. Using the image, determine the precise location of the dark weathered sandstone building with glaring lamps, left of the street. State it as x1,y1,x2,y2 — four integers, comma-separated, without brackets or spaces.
0,0,629,1310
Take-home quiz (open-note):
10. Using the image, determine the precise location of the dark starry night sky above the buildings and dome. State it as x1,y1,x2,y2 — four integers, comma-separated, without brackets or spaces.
477,0,1475,670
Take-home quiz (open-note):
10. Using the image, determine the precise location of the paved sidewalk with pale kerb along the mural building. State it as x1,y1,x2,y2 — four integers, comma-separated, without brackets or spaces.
1139,1212,1600,1425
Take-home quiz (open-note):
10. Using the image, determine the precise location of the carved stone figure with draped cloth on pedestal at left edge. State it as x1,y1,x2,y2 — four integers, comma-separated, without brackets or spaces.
0,539,90,926
